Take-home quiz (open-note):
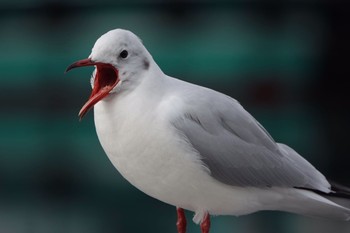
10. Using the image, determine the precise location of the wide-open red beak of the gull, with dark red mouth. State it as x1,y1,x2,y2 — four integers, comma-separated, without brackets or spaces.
66,58,120,119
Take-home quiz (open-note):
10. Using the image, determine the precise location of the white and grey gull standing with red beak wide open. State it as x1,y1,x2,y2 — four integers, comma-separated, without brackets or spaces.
66,29,350,233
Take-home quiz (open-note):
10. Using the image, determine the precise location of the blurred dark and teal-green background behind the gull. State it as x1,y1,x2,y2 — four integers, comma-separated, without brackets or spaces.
0,0,350,233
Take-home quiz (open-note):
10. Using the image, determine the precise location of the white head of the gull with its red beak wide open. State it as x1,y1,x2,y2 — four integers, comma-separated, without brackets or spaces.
66,29,152,119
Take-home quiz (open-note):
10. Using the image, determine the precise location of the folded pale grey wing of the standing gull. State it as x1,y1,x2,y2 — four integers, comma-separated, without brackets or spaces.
172,95,330,193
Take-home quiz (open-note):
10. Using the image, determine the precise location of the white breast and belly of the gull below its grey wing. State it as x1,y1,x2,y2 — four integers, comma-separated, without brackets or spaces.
94,77,296,222
